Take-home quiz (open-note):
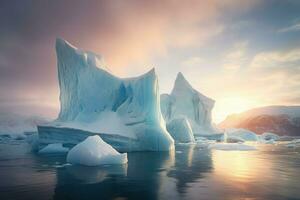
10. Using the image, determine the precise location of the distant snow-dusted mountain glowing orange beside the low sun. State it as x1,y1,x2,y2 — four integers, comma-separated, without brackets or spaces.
218,106,300,136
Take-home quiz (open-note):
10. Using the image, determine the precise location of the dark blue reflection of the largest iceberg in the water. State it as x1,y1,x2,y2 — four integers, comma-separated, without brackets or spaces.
54,152,173,199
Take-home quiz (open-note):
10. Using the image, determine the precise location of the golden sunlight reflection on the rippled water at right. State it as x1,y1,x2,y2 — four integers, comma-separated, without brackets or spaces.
186,145,300,200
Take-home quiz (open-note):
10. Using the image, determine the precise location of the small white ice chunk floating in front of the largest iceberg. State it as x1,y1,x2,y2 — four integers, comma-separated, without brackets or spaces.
67,135,127,166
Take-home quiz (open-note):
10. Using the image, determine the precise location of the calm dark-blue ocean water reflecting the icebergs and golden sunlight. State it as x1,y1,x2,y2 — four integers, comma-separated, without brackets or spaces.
0,138,300,200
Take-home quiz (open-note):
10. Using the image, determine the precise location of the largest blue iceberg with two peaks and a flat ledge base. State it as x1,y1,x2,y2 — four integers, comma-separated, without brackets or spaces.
38,39,174,151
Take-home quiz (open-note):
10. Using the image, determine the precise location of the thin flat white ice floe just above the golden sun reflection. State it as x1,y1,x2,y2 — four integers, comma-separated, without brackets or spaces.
208,143,257,151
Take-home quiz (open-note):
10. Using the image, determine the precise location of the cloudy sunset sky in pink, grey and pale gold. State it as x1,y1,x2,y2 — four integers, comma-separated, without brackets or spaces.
0,0,300,123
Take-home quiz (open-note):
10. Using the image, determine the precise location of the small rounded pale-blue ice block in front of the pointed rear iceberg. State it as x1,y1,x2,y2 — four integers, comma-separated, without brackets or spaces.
167,117,195,143
